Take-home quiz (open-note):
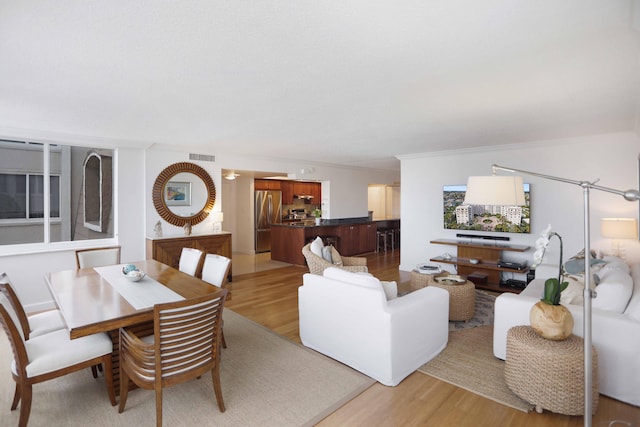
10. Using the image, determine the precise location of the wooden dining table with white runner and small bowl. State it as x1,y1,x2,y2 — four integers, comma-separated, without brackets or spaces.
45,259,218,402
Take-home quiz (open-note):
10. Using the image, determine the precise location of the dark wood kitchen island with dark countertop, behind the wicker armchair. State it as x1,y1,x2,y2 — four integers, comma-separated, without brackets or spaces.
271,217,400,265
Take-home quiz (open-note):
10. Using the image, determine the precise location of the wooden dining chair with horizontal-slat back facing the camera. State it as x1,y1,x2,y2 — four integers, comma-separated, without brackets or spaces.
118,289,227,426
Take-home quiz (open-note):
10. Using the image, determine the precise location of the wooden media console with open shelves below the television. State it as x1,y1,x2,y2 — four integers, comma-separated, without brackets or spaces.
429,239,529,294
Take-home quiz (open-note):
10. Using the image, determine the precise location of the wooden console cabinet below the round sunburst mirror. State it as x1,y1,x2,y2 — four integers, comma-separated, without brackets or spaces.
147,231,233,299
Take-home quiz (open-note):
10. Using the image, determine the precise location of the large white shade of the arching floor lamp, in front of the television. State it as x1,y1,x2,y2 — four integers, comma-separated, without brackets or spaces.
464,176,525,206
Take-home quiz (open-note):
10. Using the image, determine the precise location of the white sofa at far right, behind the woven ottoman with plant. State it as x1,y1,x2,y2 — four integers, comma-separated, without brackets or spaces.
493,264,640,406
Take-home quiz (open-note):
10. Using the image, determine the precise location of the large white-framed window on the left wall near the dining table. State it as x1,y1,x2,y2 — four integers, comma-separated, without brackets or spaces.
0,140,115,246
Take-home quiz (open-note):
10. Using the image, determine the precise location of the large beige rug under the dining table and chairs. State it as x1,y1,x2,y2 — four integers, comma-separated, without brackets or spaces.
0,310,375,427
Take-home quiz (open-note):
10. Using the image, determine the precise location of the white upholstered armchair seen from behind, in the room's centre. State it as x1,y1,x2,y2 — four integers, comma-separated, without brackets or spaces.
298,267,449,386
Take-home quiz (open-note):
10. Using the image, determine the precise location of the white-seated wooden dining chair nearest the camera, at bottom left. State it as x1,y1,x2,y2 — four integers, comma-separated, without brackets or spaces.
0,293,116,427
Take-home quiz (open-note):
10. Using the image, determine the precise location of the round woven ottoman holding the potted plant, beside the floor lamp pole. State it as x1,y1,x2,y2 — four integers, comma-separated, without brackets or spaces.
504,326,599,415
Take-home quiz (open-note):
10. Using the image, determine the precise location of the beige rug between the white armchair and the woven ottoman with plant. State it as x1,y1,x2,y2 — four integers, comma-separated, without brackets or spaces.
418,325,533,412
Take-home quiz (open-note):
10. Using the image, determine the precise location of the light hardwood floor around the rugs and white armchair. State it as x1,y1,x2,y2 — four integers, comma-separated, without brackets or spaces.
226,251,640,427
